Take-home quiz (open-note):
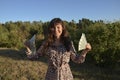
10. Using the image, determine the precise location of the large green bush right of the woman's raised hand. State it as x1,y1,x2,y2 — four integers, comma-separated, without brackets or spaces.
88,22,120,66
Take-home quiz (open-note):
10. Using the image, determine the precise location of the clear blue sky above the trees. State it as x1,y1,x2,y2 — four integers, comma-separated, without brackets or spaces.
0,0,120,23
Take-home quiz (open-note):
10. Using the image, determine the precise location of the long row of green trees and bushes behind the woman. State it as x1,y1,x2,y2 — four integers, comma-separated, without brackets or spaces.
0,18,120,67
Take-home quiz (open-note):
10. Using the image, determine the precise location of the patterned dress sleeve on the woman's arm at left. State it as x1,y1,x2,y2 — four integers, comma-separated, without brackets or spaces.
27,42,45,59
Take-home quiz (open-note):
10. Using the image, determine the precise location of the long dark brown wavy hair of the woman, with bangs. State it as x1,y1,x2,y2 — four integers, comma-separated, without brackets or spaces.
45,18,71,51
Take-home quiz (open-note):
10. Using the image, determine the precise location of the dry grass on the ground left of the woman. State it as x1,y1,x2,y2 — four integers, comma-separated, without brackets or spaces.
0,49,47,80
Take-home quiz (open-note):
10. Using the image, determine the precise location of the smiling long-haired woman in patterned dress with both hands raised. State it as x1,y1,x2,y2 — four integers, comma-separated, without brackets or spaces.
26,18,91,80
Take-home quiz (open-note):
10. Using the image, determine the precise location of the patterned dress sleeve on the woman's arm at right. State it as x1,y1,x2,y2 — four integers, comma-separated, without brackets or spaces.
70,44,88,63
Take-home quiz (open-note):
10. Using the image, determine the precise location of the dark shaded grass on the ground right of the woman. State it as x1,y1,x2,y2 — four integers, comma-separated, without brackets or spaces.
72,63,120,80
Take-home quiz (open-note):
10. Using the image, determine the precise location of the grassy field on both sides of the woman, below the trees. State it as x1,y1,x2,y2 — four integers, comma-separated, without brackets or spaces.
0,48,120,80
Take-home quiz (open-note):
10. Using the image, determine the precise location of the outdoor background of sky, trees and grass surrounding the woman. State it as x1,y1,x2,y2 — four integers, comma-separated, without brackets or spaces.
0,0,120,80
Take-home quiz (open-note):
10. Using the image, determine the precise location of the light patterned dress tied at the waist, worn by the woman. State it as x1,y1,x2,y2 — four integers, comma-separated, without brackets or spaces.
27,42,87,80
